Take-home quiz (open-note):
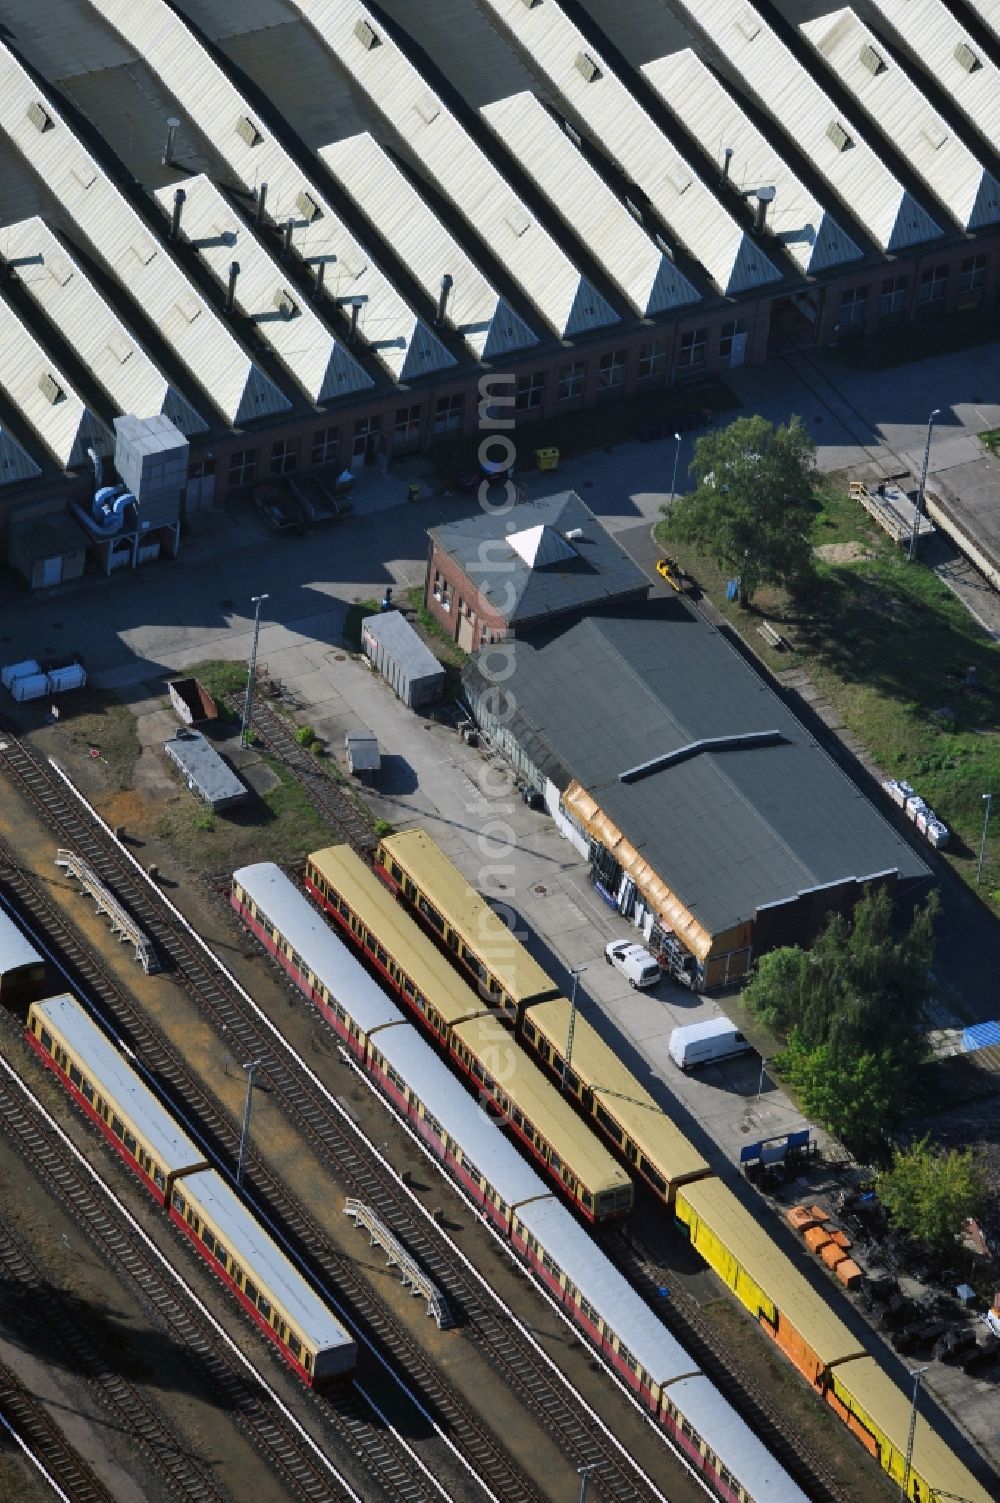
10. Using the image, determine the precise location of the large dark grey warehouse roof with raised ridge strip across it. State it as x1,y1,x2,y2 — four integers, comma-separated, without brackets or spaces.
472,600,929,933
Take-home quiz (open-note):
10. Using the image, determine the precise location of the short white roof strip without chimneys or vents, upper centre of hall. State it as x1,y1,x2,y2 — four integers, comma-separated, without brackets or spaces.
480,93,701,316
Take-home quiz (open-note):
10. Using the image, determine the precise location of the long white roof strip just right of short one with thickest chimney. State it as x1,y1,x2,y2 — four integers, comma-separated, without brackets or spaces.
667,0,941,251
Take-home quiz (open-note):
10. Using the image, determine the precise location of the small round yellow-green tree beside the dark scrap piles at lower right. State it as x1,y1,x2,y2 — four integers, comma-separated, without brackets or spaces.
877,1138,986,1257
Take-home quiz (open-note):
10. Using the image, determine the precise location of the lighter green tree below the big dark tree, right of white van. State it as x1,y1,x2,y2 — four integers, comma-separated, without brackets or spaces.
774,1030,911,1157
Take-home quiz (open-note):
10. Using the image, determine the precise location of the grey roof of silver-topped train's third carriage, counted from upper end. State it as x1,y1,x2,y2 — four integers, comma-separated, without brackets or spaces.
517,1201,699,1383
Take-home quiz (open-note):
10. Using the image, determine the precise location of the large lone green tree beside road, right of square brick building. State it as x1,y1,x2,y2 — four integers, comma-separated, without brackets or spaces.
663,416,817,606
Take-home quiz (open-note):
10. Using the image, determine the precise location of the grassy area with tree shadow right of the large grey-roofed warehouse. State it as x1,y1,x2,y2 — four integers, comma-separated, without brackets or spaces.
652,475,1000,914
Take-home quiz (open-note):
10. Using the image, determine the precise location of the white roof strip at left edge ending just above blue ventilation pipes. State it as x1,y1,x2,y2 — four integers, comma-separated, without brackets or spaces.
0,294,114,469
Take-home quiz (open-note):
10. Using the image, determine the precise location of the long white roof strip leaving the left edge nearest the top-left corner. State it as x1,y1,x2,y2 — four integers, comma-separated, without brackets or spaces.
0,44,292,422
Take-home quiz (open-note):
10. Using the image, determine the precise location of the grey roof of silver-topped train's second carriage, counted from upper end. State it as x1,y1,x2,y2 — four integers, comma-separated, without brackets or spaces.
374,1025,553,1205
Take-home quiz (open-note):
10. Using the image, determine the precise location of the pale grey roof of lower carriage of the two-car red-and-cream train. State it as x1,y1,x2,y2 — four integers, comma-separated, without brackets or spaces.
177,1169,355,1366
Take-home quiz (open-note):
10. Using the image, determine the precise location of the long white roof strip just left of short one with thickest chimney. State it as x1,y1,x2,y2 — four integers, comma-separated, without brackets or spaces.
483,0,782,293
